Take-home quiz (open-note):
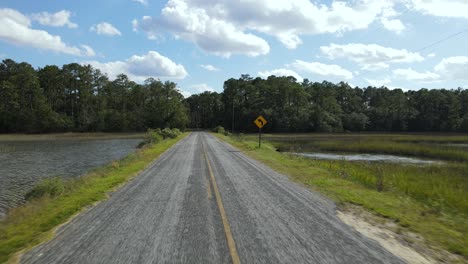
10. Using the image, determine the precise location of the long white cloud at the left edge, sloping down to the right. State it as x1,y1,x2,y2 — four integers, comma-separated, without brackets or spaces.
0,8,94,56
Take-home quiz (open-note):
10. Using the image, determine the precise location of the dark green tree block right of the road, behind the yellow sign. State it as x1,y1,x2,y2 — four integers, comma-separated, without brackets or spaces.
186,75,468,132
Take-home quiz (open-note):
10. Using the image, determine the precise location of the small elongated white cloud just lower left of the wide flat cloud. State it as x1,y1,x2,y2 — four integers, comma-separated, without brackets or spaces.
291,60,353,80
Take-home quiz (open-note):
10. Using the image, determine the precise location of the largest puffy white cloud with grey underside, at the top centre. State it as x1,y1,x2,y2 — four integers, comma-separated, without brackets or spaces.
133,0,404,54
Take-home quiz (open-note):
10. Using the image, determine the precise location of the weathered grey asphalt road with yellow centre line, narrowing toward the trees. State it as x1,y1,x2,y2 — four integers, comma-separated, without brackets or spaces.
21,132,402,264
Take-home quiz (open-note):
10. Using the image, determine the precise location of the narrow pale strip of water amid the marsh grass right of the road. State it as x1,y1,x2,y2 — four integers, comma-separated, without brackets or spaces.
288,152,442,165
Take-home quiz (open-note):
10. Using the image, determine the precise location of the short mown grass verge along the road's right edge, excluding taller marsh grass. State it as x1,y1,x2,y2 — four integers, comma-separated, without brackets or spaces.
215,134,468,262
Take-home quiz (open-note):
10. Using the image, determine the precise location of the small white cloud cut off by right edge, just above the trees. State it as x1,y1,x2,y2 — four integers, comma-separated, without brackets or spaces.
434,56,468,80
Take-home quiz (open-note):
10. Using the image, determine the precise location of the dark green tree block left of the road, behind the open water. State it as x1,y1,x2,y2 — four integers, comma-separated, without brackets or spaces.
0,59,188,133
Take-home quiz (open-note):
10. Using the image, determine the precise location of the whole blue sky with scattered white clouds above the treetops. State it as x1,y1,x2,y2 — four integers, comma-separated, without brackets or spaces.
0,0,468,97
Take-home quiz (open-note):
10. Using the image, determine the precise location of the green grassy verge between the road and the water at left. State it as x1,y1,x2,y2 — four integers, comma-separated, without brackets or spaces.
0,133,188,263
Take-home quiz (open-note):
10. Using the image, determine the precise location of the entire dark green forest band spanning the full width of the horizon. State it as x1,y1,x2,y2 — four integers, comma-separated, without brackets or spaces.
0,59,468,133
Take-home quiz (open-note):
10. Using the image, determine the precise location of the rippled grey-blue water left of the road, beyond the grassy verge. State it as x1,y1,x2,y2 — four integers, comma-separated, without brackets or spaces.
0,139,141,218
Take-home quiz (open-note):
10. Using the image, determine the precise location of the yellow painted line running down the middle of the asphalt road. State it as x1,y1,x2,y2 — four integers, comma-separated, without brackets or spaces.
203,144,240,264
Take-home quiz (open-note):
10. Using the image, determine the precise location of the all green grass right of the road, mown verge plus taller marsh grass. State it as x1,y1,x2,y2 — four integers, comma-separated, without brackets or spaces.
217,134,468,259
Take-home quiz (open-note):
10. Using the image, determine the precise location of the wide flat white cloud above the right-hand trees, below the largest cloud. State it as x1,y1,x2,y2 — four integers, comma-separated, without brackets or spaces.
320,43,424,70
